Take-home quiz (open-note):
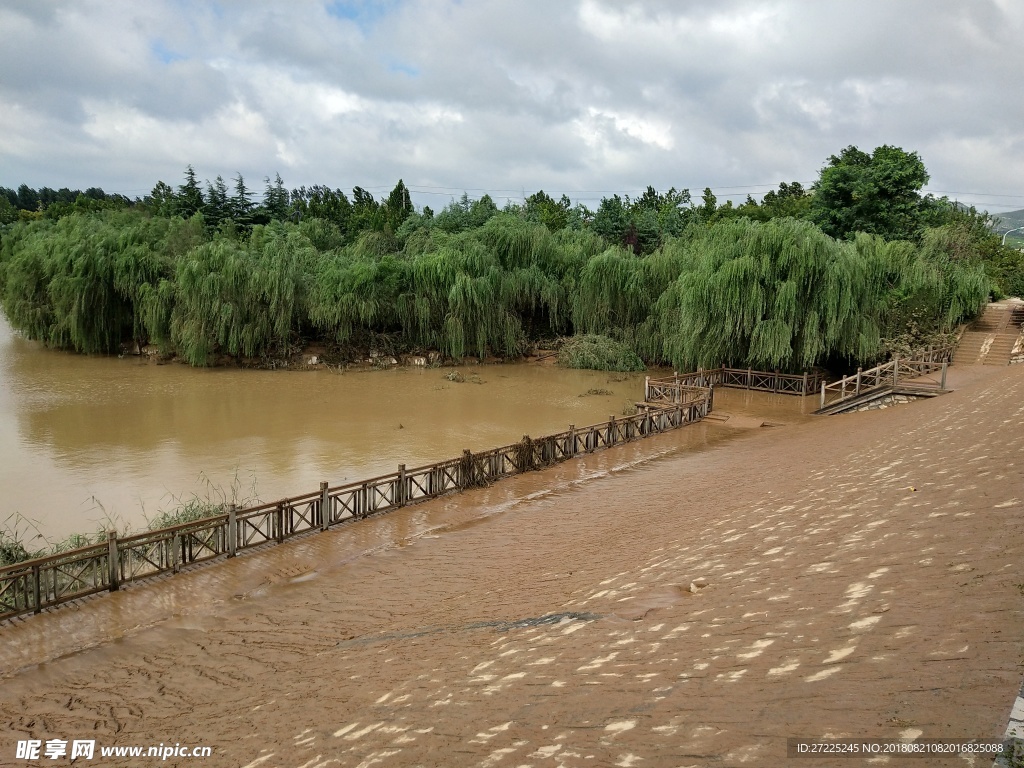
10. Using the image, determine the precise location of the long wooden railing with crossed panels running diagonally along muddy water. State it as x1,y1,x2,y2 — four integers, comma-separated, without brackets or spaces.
0,385,712,620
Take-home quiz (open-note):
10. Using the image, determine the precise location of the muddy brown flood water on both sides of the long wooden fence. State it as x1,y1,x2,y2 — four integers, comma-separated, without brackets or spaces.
0,309,816,671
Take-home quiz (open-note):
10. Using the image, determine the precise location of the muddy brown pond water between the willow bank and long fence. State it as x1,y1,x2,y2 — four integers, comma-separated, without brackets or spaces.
0,317,655,543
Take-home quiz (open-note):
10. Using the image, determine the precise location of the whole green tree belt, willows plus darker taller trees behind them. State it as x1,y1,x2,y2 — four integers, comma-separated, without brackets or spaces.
0,146,1024,370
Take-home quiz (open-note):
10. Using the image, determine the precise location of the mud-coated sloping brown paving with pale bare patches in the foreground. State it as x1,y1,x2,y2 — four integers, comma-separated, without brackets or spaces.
0,366,1024,768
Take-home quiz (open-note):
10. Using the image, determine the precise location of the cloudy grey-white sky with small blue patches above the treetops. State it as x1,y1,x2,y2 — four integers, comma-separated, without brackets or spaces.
0,0,1024,212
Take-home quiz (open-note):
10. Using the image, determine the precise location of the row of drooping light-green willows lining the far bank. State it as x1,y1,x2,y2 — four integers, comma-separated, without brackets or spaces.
0,202,989,371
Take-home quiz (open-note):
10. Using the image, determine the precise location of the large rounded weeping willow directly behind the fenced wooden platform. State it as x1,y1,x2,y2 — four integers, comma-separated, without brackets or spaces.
656,219,884,371
